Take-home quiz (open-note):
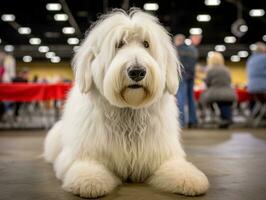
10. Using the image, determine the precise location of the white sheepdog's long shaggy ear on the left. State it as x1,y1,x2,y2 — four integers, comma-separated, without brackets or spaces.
72,41,95,93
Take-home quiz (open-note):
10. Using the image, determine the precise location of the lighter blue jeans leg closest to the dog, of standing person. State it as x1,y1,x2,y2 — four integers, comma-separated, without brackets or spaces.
176,80,186,127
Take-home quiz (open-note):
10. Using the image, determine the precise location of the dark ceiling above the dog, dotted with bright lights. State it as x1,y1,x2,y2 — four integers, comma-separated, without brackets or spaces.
0,0,266,59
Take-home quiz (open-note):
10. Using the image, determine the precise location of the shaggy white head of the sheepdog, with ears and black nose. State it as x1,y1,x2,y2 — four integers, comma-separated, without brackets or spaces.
73,9,180,108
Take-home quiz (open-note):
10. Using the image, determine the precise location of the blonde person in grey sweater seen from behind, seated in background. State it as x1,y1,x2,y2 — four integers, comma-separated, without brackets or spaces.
201,52,236,128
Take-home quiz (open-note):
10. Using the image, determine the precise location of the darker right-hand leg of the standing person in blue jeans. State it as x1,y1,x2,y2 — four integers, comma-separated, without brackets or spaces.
187,80,197,125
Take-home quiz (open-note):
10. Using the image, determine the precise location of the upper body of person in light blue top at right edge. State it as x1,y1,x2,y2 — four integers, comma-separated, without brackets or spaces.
247,42,266,94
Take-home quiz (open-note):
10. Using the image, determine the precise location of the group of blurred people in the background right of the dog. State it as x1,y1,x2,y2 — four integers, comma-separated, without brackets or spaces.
174,34,266,128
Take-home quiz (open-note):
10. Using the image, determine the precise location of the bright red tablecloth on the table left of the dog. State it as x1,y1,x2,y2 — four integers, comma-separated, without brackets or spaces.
0,83,72,102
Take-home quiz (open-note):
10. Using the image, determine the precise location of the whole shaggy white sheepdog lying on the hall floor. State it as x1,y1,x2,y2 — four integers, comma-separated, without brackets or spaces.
44,9,209,198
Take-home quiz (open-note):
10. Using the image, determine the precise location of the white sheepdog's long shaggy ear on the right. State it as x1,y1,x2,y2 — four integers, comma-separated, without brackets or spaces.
166,41,181,95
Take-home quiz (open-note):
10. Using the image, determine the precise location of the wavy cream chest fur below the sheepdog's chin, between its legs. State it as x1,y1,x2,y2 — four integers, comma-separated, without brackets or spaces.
101,108,156,181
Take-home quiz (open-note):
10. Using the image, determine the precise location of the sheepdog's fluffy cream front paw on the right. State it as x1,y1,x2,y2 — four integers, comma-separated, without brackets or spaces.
148,160,209,196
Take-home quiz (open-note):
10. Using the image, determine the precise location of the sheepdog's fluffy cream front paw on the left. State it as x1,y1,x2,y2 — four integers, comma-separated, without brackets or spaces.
63,161,120,198
